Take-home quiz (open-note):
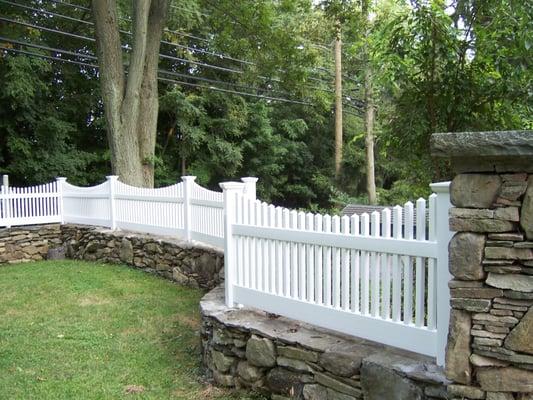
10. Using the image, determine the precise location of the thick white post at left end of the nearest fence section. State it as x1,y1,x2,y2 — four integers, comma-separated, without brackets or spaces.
220,182,245,307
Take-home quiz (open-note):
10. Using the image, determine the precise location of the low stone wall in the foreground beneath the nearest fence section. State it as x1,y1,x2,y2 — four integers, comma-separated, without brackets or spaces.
200,288,448,400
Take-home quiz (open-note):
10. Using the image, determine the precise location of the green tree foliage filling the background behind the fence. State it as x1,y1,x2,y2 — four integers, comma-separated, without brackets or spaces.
0,0,533,210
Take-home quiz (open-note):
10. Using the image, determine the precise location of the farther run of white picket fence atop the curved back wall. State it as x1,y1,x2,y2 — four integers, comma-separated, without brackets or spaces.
0,176,257,247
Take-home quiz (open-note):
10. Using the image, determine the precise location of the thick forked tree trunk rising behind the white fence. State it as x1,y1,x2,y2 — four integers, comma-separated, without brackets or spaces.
92,0,168,187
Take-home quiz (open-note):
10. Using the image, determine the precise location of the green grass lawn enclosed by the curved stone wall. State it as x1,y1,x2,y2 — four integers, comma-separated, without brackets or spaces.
0,261,260,400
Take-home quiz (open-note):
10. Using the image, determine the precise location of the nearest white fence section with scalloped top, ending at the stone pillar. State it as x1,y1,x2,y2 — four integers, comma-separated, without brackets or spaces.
221,183,451,365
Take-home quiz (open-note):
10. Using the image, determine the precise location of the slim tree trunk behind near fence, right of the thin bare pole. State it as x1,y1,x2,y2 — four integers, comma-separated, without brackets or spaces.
361,0,377,204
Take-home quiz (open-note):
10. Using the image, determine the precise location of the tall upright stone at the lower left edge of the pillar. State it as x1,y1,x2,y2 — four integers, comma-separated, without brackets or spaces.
446,309,472,385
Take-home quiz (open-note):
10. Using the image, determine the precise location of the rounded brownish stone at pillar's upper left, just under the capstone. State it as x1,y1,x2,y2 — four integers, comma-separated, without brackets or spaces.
450,174,501,208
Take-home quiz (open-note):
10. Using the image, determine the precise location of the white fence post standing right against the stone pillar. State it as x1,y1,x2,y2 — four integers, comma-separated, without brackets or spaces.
430,182,453,365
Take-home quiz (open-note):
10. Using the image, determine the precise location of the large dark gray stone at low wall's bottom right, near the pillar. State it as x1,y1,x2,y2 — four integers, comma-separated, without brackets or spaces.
361,362,424,400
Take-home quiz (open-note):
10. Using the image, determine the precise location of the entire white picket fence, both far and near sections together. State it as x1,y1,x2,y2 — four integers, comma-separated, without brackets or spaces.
0,176,452,365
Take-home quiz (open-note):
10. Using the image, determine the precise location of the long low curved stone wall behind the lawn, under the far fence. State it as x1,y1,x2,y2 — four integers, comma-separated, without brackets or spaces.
0,224,224,289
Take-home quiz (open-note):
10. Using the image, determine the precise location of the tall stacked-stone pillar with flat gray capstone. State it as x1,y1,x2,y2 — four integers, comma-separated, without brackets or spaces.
431,131,533,400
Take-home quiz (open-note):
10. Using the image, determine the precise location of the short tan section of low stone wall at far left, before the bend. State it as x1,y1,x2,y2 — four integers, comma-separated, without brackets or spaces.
0,225,62,265
